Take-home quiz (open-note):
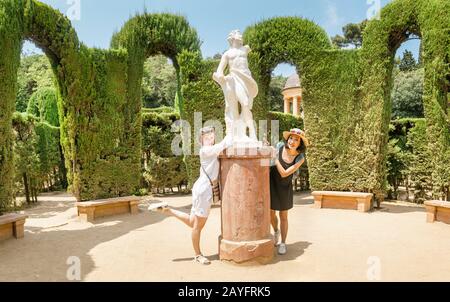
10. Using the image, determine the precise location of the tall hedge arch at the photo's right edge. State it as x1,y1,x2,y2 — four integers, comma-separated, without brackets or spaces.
355,0,450,199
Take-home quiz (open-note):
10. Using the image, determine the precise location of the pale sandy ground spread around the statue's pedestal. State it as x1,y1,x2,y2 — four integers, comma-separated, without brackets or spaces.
0,194,450,282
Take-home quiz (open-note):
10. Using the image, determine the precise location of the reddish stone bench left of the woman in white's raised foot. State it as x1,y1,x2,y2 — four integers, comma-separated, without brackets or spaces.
76,196,141,222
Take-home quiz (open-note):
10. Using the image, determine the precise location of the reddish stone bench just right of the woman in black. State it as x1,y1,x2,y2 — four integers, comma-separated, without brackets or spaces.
312,191,373,212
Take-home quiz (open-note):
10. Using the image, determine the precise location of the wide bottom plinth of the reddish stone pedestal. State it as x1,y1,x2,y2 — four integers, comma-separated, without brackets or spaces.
219,236,274,264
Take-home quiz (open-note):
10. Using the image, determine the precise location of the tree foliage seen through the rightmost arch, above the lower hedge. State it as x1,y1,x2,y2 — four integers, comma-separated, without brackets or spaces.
392,69,424,119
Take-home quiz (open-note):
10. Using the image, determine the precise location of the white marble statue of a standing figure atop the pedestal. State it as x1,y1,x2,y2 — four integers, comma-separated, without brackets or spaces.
213,30,258,143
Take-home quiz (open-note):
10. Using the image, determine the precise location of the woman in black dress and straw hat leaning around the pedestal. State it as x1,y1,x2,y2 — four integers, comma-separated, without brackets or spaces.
270,129,308,255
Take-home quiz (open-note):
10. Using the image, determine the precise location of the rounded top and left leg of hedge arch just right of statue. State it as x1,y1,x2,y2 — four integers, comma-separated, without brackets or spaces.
244,17,331,120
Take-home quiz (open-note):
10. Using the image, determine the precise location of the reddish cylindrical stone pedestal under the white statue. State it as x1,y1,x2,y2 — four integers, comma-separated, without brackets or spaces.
219,147,274,264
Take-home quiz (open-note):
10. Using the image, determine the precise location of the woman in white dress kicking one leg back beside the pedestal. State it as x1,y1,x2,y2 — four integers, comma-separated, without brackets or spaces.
149,127,232,264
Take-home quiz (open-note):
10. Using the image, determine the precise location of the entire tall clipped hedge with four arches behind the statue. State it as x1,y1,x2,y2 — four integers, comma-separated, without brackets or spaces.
0,0,450,211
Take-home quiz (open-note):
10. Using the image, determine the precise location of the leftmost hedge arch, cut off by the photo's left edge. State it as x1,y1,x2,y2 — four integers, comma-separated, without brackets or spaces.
0,0,79,209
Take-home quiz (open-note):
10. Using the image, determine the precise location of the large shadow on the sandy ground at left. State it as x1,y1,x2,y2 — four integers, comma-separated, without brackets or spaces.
0,197,192,281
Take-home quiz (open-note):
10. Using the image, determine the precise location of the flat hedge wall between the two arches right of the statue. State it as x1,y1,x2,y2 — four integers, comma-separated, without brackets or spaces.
302,50,364,191
